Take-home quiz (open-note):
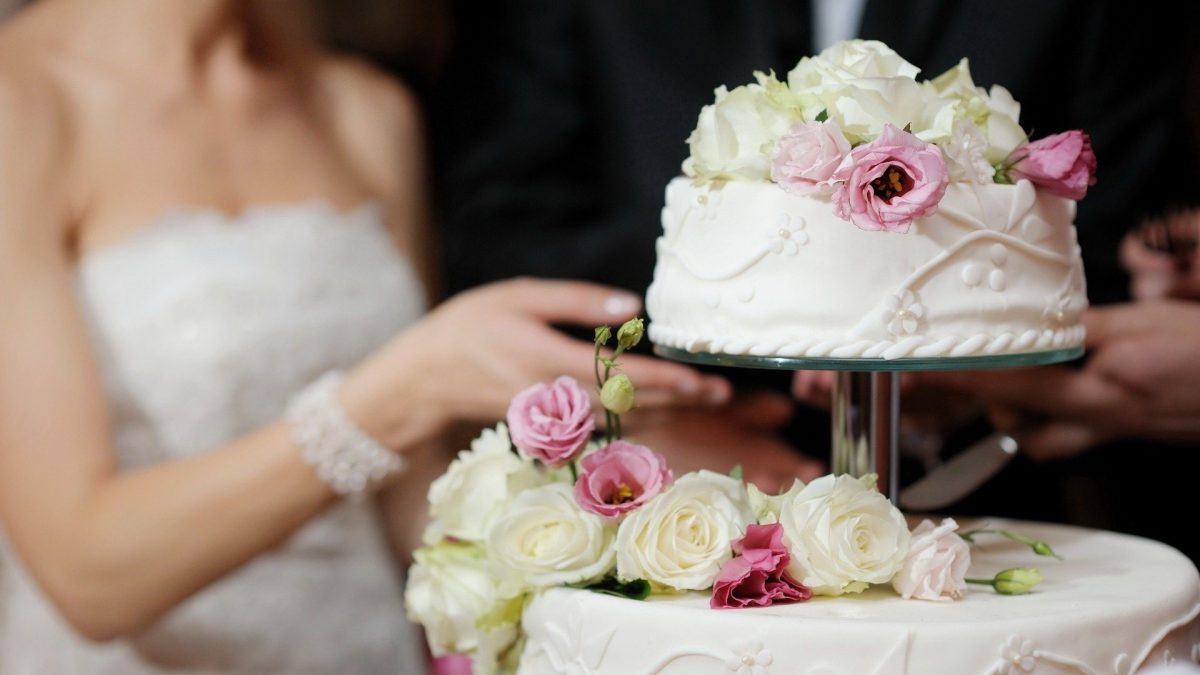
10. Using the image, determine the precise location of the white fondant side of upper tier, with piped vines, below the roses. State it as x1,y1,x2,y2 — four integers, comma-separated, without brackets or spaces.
647,178,1087,358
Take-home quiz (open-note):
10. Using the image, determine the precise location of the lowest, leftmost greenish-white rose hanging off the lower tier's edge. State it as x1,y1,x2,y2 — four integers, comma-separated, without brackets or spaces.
404,543,521,656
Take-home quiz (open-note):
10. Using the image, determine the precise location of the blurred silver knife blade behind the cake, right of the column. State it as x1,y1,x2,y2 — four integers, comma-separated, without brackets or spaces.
900,434,1020,510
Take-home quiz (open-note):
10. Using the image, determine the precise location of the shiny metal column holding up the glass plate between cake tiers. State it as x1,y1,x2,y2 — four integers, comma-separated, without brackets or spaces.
832,371,900,503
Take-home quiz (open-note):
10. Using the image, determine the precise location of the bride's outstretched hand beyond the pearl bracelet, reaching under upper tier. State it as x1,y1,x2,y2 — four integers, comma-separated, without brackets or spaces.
341,279,731,444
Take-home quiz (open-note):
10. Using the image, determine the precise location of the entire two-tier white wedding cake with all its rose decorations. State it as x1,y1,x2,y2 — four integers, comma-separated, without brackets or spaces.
406,41,1200,675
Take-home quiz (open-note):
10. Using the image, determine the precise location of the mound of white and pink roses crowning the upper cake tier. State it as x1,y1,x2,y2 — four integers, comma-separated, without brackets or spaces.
683,40,1096,233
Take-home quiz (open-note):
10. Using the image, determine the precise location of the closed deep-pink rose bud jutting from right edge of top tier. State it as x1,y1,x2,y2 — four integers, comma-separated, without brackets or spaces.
1009,130,1096,201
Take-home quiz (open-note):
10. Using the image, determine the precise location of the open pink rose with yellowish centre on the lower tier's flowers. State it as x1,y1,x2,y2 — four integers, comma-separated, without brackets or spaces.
575,441,672,518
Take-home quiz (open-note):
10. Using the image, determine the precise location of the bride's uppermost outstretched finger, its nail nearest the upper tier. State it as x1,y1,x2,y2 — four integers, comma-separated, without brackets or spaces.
488,279,642,325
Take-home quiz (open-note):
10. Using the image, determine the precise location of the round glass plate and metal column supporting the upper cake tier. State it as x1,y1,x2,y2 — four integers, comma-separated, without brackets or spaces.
654,345,1084,503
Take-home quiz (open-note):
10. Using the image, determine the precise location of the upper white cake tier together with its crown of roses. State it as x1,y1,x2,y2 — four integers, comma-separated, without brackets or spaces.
647,41,1096,359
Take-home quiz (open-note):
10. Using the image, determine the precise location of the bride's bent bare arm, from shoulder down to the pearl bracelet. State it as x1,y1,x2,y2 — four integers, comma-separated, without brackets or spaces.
0,82,428,639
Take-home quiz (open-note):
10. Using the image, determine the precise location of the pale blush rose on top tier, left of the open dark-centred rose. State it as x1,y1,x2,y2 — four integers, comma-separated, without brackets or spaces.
770,121,850,195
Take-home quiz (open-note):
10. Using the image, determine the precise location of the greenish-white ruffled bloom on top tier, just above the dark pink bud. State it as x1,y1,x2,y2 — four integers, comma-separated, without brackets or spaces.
923,59,1027,163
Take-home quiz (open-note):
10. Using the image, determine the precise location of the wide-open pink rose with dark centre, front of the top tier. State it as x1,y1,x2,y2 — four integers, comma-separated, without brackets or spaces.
833,125,949,233
